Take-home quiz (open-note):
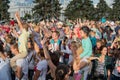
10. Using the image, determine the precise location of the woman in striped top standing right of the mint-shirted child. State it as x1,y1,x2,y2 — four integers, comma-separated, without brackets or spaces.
94,46,108,80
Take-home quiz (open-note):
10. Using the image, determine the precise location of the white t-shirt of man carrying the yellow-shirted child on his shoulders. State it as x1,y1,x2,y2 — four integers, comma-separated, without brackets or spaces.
16,59,28,80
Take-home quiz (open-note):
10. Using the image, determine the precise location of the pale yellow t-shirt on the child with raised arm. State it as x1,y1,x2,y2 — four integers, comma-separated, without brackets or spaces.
18,29,29,53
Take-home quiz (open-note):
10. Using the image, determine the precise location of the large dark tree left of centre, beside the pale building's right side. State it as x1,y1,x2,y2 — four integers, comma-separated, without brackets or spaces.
33,0,62,19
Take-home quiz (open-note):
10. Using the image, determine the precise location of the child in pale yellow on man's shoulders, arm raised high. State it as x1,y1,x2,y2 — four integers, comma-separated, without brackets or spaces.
10,13,29,71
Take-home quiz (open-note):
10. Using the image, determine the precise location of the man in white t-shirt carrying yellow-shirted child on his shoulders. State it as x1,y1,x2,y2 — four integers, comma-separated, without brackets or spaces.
10,43,28,80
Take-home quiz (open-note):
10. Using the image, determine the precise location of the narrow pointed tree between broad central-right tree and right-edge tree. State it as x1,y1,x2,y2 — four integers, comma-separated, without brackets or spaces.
95,0,111,20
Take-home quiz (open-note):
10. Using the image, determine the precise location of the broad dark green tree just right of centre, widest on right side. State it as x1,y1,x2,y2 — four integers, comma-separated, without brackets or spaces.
65,0,94,19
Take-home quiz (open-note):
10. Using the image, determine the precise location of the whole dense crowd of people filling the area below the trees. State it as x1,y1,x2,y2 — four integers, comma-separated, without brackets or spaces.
0,12,120,80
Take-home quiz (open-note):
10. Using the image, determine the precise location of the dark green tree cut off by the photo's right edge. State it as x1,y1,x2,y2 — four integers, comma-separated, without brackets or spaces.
112,0,120,20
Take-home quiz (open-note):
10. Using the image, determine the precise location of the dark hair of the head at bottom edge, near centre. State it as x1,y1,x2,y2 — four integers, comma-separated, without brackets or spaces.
55,65,69,80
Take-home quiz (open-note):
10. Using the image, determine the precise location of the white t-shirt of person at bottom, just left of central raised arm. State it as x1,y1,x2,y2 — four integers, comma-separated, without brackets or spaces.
37,60,48,80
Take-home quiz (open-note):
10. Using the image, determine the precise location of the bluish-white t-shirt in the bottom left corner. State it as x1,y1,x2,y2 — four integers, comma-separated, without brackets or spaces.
0,58,12,80
